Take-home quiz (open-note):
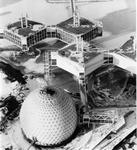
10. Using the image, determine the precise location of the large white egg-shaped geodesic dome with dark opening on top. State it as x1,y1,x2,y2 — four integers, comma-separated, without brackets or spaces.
20,87,77,146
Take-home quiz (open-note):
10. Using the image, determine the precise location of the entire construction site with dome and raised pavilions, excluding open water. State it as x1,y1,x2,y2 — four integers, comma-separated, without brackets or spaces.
0,0,137,150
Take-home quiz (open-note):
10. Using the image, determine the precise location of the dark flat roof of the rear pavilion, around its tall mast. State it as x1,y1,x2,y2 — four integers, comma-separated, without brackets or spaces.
57,17,95,34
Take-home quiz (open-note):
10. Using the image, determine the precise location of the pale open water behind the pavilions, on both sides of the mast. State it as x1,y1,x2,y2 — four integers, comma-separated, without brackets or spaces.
0,0,134,26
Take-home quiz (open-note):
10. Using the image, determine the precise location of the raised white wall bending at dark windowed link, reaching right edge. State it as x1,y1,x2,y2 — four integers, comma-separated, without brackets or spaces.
85,53,136,75
